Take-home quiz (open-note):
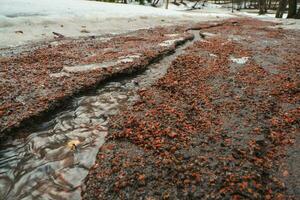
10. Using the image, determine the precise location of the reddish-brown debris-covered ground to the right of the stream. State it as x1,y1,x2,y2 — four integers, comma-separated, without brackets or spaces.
82,19,300,199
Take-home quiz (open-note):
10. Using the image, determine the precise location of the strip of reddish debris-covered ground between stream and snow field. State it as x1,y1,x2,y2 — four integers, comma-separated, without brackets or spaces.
0,26,193,138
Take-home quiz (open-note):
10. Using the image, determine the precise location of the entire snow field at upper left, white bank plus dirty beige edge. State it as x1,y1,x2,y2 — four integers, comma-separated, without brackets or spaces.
0,0,232,48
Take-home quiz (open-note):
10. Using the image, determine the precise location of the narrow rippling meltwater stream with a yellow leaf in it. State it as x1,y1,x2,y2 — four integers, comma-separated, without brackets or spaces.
0,31,200,200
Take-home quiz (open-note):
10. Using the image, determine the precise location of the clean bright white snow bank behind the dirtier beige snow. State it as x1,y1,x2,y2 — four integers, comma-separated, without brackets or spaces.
0,0,227,18
